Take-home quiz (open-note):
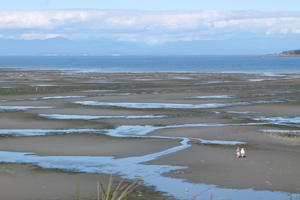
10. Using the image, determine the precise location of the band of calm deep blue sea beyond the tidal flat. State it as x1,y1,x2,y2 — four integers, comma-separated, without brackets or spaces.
0,56,300,73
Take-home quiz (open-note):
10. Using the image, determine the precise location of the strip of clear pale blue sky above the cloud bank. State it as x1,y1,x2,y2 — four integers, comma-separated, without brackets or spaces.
0,0,300,11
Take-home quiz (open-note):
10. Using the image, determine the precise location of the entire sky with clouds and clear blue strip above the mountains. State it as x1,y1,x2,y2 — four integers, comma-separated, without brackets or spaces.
0,0,300,45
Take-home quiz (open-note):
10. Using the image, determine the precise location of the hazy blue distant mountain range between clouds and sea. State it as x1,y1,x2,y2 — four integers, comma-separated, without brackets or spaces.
0,37,300,56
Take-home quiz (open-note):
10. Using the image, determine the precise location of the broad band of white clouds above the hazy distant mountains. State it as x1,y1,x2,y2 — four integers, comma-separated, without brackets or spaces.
0,10,300,44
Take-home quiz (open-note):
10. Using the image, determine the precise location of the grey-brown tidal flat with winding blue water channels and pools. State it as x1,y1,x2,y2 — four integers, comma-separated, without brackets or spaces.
0,69,300,200
